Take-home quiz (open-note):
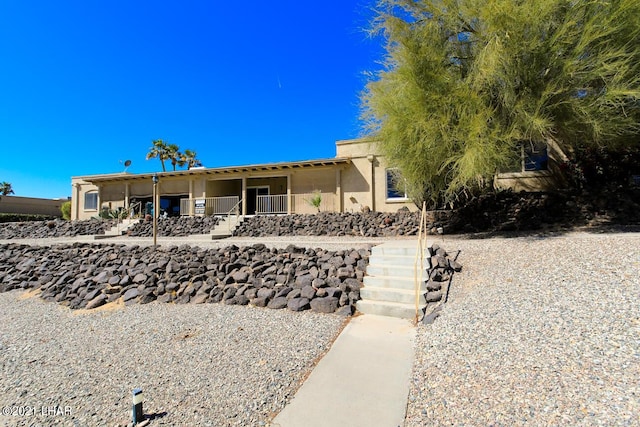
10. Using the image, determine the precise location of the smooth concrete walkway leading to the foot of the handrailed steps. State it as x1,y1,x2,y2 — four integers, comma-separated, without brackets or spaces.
271,314,415,427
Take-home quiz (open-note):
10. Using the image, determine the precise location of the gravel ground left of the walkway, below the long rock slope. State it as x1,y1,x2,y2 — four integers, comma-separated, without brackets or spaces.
0,291,344,426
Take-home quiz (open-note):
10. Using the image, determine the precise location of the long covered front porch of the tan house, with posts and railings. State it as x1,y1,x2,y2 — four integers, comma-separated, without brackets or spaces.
72,158,351,218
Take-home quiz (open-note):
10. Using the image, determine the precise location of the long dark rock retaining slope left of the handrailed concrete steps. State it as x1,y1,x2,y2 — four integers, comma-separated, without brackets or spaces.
0,243,370,315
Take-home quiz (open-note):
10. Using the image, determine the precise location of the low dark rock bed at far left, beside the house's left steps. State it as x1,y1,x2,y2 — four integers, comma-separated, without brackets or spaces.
0,219,116,239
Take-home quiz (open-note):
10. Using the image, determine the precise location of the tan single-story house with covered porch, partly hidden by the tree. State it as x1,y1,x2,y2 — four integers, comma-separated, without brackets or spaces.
71,139,564,219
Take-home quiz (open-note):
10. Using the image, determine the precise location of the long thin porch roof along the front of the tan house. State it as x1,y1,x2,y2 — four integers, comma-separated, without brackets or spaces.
76,157,351,184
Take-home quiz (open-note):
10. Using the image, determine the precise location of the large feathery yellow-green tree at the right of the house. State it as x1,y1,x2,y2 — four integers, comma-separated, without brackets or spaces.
361,0,640,205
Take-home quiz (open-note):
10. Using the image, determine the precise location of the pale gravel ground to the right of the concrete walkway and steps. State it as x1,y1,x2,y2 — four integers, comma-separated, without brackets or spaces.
406,233,640,426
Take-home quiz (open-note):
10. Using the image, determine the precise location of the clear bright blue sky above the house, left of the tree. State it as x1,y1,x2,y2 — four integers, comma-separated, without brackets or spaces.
0,0,383,198
